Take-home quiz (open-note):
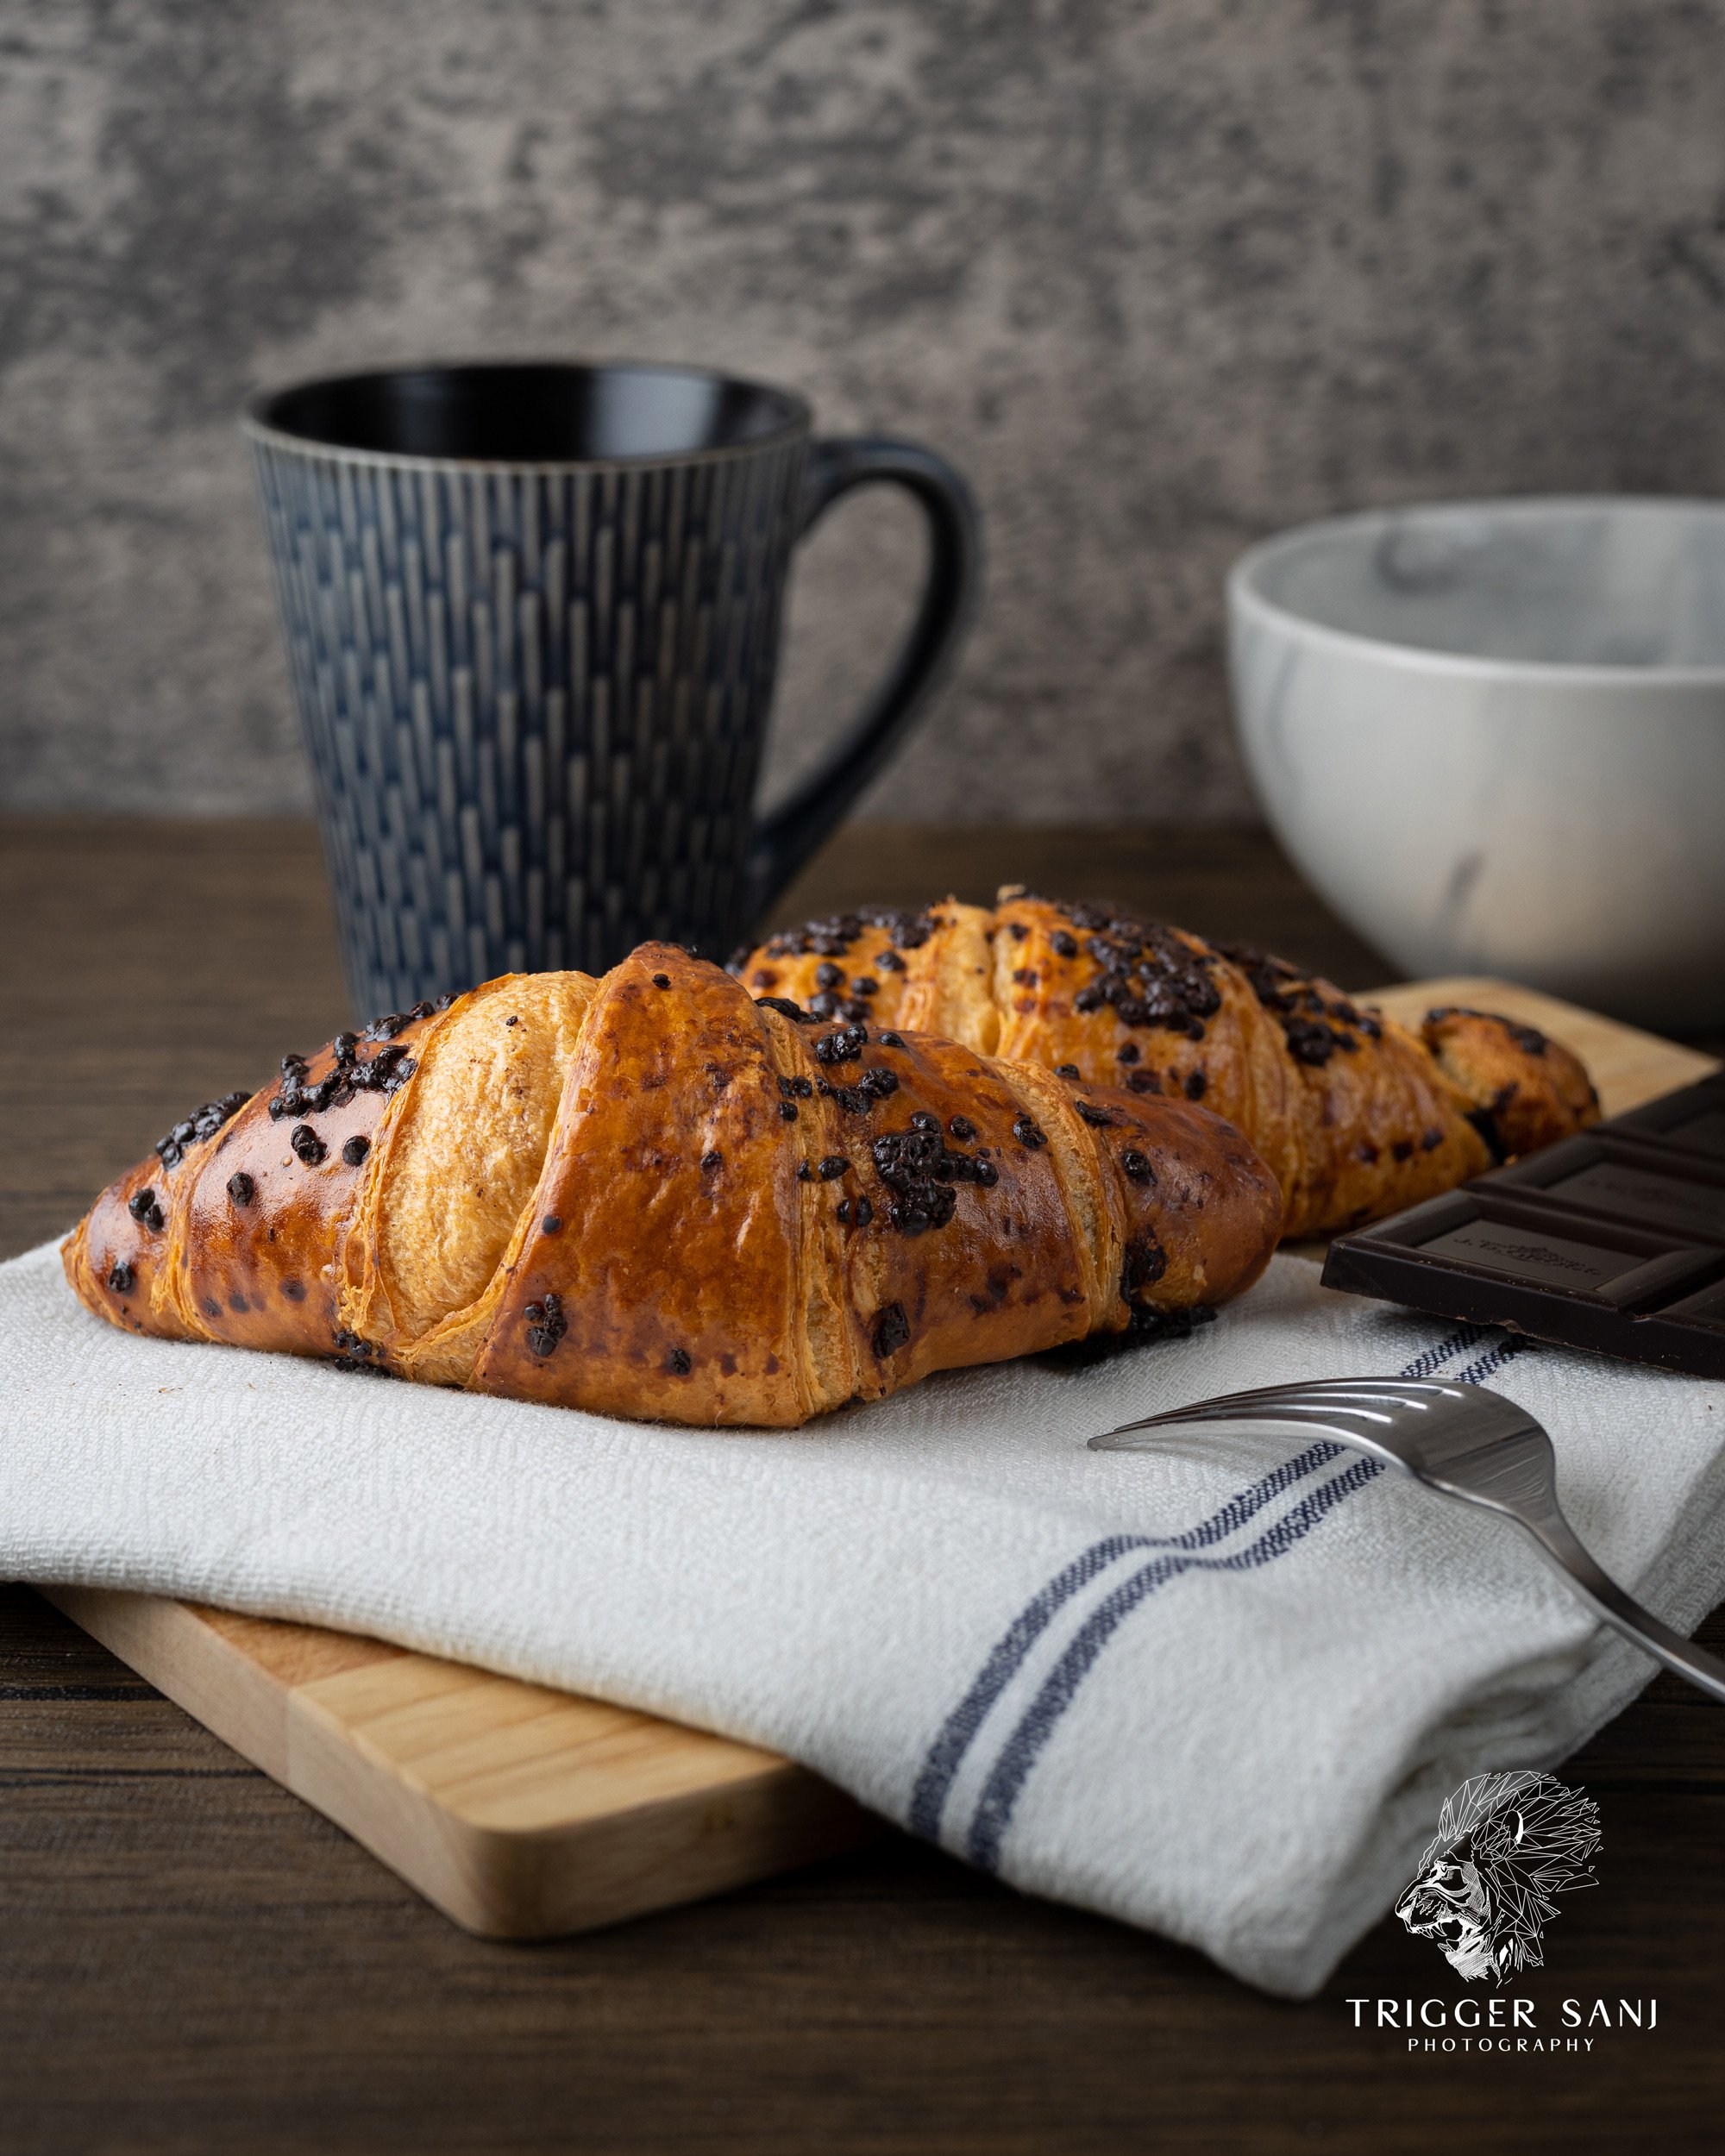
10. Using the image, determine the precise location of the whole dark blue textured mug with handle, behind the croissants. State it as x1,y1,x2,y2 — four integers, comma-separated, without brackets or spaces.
246,362,982,1018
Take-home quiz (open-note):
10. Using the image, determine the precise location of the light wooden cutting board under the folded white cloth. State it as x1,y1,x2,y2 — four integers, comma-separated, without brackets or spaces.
50,979,1719,1939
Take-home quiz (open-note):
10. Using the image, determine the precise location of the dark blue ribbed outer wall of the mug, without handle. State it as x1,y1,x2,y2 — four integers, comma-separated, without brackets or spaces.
253,436,805,1016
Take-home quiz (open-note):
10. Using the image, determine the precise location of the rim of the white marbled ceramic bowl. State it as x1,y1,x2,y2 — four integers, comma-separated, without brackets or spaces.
1227,494,1725,690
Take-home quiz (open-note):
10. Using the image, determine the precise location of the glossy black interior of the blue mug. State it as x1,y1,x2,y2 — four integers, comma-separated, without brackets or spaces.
254,365,806,464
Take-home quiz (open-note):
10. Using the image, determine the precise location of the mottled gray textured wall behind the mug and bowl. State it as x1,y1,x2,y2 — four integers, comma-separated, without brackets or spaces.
0,0,1725,819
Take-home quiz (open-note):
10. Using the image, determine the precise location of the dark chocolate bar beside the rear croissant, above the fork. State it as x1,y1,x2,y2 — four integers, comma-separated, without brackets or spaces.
1324,1072,1725,1378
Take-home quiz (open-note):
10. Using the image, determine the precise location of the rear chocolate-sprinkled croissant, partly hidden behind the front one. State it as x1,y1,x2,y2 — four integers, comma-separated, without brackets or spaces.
731,887,1600,1236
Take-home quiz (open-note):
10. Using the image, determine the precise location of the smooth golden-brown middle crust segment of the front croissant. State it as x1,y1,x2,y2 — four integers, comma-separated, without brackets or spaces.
470,944,815,1423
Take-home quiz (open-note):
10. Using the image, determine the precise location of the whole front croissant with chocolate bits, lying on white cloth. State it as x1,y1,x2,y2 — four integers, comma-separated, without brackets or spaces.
65,944,1281,1427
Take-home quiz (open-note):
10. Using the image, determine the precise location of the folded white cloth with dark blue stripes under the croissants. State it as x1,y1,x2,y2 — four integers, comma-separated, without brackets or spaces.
0,1246,1725,1996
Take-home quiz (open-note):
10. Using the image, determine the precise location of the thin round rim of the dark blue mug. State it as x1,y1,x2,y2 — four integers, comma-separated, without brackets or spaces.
240,358,815,477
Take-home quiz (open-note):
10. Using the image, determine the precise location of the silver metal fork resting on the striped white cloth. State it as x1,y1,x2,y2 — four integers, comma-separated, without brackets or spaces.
1091,1378,1725,1702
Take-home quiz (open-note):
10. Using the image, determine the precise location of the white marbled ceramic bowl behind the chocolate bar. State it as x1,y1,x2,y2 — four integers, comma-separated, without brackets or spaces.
1227,496,1725,1033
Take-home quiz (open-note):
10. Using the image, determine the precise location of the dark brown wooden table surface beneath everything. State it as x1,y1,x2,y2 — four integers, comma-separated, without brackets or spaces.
0,818,1725,2156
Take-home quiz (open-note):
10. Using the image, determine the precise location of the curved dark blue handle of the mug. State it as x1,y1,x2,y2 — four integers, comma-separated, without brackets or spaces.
744,436,983,923
